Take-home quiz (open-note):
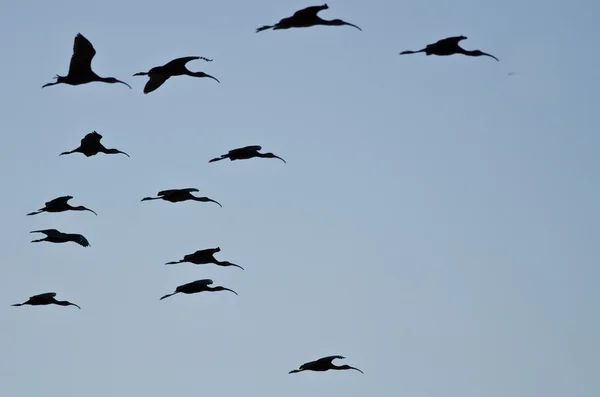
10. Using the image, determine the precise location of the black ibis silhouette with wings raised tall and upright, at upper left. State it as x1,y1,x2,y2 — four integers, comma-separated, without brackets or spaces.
42,33,131,88
